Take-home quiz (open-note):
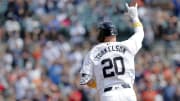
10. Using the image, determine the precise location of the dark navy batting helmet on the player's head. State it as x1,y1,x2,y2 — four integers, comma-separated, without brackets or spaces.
98,21,118,42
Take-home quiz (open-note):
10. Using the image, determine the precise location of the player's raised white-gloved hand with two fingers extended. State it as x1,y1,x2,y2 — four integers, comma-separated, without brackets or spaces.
126,3,138,19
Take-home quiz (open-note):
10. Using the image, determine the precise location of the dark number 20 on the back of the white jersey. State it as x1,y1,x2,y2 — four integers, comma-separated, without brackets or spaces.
101,57,125,78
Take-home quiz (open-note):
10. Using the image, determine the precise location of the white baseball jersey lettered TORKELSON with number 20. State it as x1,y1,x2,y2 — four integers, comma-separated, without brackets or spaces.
80,22,144,99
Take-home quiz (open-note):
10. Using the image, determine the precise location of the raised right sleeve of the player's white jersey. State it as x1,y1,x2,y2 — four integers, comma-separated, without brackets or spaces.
124,20,144,55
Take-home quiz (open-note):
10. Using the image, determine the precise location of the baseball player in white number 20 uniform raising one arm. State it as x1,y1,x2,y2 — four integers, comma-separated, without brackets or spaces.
80,4,144,101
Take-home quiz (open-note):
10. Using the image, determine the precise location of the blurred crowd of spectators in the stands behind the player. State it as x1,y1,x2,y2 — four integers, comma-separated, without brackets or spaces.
0,0,180,101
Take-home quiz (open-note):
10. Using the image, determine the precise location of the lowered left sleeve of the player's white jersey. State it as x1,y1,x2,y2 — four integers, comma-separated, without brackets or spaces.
80,54,93,85
